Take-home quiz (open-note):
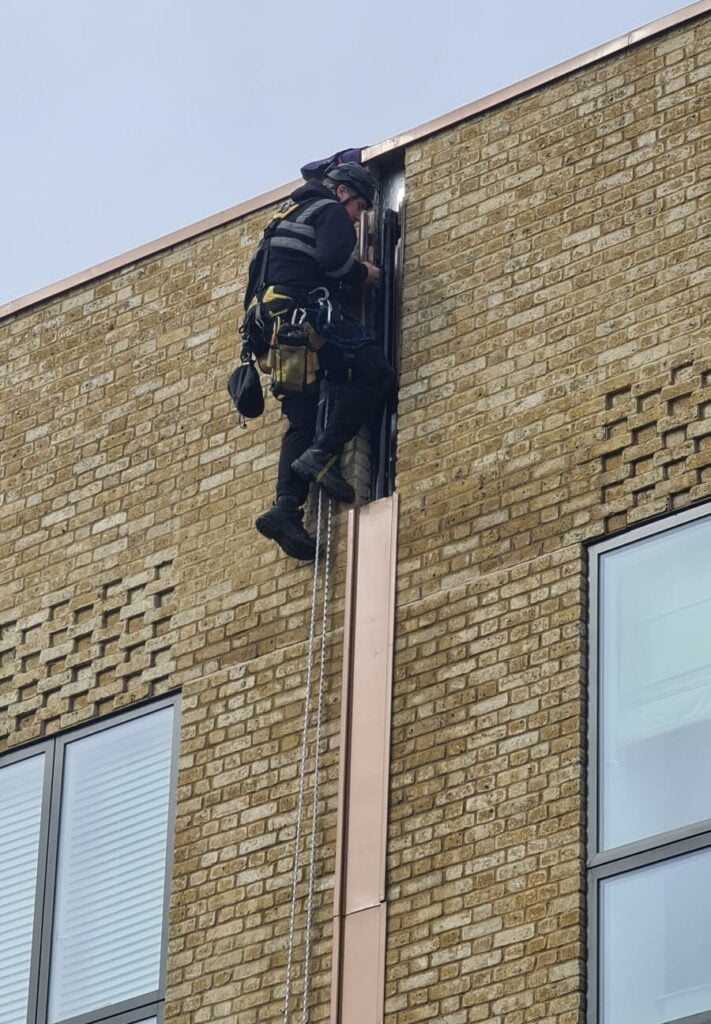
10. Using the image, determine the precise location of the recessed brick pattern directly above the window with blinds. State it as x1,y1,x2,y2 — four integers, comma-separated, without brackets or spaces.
0,560,175,748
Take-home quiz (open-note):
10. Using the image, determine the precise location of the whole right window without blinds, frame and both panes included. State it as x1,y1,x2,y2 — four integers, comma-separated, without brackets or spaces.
588,506,711,1024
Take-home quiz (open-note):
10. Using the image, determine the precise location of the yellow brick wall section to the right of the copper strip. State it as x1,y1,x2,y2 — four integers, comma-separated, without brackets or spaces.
393,19,711,1024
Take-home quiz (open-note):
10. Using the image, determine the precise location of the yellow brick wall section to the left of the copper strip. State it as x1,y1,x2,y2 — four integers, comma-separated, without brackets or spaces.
0,201,345,1024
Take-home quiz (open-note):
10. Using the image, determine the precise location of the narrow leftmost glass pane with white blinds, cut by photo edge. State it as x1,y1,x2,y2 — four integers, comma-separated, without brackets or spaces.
0,754,44,1024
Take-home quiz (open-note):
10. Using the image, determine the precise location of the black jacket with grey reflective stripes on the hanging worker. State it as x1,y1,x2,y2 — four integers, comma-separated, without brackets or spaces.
247,184,368,300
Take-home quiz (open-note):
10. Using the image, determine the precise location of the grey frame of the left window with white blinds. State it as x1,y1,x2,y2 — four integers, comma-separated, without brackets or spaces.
0,693,180,1024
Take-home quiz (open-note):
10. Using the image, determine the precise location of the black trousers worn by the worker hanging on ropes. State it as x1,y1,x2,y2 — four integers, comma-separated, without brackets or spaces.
277,341,395,505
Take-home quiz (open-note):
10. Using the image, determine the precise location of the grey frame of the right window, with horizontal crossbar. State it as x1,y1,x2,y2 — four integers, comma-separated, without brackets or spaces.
586,502,711,1024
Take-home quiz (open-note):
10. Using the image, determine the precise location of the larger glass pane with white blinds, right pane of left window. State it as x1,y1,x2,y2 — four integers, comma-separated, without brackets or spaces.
49,708,173,1022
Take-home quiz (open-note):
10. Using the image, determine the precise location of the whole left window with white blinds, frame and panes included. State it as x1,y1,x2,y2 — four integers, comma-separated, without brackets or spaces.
0,699,177,1024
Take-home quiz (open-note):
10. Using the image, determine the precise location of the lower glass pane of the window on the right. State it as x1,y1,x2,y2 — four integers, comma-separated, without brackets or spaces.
600,850,711,1024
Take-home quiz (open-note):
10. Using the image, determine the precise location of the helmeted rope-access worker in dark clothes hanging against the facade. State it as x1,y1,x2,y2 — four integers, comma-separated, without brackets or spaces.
243,161,394,561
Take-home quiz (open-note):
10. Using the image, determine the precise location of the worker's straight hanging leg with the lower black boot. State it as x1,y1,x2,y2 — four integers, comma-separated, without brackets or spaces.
255,384,319,561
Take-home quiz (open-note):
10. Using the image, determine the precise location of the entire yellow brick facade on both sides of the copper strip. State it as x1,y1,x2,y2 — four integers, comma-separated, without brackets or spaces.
0,18,711,1024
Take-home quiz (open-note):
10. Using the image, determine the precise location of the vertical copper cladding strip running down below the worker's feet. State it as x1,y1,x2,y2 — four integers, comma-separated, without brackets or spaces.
331,495,398,1024
